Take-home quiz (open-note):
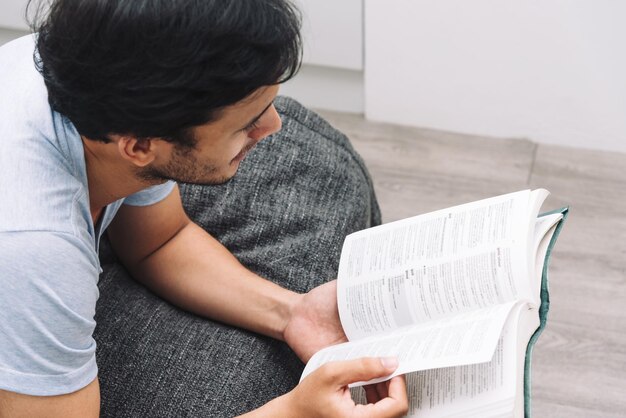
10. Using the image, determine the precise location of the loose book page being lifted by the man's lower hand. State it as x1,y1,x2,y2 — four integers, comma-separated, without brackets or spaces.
302,302,519,383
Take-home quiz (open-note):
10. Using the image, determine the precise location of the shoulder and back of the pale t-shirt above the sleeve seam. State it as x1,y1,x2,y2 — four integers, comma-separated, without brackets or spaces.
0,35,90,240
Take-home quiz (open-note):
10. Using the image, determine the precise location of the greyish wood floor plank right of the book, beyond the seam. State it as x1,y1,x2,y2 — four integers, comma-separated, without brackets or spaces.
530,145,626,417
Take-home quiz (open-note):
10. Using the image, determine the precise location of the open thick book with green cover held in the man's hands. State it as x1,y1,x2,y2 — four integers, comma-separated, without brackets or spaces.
302,189,567,418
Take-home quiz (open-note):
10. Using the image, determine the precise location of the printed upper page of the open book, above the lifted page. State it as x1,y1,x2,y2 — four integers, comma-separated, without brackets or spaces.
337,190,534,341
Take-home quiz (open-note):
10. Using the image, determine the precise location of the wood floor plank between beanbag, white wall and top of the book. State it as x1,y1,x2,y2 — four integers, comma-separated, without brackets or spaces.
320,111,536,222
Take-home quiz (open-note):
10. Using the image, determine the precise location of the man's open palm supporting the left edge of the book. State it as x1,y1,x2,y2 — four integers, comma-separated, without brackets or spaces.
283,280,347,363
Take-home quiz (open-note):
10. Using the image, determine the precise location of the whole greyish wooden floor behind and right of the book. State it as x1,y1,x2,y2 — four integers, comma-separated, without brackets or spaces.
319,111,626,418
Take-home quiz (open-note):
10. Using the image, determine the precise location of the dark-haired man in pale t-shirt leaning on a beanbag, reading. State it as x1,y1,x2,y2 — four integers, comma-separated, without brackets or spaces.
0,0,406,417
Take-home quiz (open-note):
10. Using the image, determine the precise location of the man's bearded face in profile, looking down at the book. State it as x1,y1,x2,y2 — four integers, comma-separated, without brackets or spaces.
140,86,281,184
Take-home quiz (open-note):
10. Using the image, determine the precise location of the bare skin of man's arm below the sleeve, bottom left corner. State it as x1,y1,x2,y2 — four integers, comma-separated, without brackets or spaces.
0,378,100,418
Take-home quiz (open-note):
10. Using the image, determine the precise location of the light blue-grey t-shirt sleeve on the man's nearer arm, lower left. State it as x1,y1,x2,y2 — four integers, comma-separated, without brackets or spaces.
0,231,98,396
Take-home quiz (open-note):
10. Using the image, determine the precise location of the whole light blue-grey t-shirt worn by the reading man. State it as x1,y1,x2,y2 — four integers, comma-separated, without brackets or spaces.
0,36,174,395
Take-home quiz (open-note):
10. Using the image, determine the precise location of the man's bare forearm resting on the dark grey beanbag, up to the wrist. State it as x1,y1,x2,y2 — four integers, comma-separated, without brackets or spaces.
109,187,303,340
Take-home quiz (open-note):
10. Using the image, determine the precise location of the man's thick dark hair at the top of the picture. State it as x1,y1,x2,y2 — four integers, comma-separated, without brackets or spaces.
29,0,301,146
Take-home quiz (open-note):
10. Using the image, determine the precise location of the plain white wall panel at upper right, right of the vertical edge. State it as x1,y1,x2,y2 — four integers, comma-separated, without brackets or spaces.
365,0,626,152
